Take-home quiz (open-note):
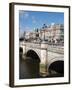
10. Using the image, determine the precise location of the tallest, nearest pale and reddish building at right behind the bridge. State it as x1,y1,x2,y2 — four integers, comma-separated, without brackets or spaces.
39,24,64,42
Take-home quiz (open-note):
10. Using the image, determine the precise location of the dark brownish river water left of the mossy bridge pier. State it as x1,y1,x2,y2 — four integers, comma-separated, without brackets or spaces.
19,53,40,79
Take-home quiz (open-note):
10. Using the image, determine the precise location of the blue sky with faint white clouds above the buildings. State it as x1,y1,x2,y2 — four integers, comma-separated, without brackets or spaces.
19,10,64,37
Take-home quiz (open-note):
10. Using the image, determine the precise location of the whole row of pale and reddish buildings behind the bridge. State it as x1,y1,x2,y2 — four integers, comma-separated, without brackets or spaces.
21,23,64,43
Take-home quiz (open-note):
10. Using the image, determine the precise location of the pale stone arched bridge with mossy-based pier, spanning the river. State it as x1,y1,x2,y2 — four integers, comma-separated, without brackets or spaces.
19,41,64,76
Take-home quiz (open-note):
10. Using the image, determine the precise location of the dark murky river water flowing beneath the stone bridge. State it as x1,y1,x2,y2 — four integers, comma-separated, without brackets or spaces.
19,53,64,79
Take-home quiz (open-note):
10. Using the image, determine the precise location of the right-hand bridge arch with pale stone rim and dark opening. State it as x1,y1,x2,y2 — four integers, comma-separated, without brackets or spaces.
48,57,64,76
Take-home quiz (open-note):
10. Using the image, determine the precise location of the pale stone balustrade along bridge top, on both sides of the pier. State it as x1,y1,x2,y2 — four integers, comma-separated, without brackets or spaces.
20,42,64,54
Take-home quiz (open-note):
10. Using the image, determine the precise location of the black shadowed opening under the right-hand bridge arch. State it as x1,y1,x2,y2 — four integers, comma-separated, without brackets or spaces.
48,60,64,76
